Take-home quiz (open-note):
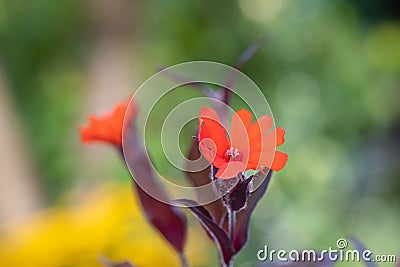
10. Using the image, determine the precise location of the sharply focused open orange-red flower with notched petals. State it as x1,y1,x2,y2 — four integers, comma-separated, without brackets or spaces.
198,107,288,179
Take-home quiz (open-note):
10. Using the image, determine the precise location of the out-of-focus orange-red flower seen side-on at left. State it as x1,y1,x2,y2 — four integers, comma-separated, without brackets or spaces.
79,101,135,146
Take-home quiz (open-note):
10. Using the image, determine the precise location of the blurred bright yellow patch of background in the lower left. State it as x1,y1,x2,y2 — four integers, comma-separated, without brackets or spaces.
0,184,207,267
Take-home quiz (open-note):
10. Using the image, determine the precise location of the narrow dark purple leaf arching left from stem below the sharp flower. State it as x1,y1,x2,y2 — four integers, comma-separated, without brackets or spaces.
175,199,235,265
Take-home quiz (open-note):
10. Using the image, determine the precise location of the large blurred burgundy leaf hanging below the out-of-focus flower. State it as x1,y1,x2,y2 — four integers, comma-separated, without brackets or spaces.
123,125,187,254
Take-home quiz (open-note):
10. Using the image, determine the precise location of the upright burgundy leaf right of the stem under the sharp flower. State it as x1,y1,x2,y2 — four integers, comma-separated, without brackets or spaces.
233,171,272,251
